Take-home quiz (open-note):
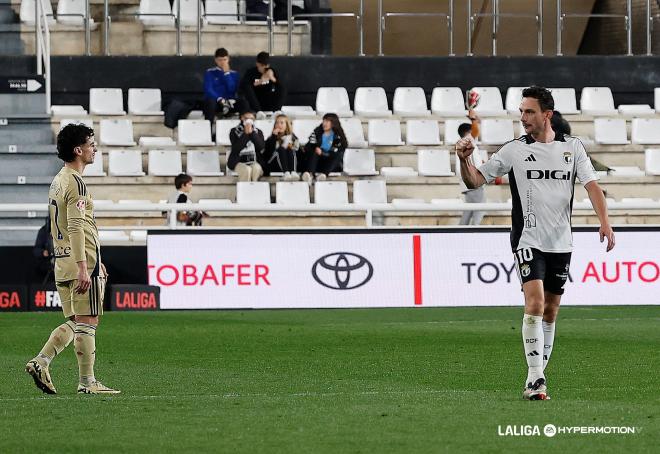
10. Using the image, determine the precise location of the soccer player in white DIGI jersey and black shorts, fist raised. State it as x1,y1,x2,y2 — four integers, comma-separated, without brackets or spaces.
456,87,614,400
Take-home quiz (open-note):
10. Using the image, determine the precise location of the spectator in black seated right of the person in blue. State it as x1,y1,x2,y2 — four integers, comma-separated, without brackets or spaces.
239,52,285,120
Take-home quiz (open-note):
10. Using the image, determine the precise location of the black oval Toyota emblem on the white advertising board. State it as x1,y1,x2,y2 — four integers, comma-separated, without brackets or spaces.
312,252,374,290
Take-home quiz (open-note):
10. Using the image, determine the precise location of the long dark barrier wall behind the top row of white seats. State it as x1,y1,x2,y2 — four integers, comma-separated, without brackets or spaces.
0,56,660,107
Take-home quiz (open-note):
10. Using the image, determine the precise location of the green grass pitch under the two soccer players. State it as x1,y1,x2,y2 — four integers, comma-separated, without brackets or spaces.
0,307,660,453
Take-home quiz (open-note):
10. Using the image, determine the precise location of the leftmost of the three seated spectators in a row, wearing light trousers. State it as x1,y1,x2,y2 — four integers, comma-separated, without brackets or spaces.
227,111,266,181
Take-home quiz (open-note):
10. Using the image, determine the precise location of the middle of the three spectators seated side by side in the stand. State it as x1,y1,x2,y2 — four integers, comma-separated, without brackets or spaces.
265,114,300,181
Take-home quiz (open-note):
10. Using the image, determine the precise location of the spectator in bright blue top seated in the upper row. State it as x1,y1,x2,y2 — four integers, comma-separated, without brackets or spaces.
204,47,239,123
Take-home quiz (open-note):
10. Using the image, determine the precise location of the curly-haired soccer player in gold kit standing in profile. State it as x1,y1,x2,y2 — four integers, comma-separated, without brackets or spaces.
25,124,119,394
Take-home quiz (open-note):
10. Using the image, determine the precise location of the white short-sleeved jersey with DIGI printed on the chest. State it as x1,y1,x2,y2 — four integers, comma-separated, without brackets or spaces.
479,134,598,252
